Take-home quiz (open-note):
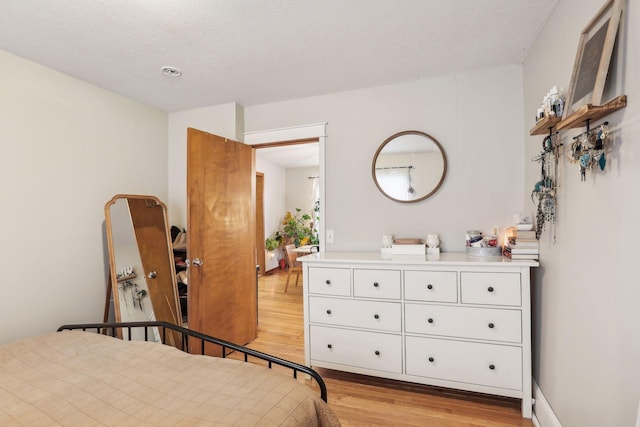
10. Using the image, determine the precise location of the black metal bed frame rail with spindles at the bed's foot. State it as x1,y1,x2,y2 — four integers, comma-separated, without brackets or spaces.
58,321,327,402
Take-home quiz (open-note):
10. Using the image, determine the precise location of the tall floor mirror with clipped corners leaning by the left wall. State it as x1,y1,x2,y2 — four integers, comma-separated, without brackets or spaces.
105,194,182,344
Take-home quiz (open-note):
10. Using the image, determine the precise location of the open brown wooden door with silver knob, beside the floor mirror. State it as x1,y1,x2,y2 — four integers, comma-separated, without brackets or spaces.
187,128,257,355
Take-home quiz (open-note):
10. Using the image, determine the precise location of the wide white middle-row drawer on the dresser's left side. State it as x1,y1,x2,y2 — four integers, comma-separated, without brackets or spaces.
309,297,402,332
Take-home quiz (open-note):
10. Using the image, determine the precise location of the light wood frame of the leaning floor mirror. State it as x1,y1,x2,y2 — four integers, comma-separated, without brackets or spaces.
104,194,182,338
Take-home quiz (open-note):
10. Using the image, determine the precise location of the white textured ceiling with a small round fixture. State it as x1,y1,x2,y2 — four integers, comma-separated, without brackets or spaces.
0,0,558,112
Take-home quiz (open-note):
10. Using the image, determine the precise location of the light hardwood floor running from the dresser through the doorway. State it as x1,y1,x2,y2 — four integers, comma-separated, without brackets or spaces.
242,270,533,427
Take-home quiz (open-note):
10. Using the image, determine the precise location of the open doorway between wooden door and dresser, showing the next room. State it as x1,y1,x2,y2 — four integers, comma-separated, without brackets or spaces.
255,141,320,332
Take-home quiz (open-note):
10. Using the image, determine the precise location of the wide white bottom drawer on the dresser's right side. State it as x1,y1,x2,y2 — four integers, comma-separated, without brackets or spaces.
405,337,522,390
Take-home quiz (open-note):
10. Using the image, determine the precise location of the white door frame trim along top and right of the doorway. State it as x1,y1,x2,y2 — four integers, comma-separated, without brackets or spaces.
244,122,327,252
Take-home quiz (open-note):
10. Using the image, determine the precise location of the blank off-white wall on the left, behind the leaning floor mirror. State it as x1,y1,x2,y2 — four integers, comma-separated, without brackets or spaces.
0,51,168,343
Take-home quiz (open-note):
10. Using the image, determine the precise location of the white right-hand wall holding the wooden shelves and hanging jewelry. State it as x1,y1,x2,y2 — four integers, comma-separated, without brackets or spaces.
523,0,640,427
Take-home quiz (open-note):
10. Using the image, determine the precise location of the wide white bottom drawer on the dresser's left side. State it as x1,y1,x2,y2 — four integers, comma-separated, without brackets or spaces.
309,325,402,374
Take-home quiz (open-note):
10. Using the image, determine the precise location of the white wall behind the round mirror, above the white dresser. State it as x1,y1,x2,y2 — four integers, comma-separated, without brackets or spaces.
245,65,524,251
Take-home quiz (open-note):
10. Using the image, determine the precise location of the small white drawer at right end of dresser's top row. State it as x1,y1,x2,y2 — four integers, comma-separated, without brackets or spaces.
460,271,522,306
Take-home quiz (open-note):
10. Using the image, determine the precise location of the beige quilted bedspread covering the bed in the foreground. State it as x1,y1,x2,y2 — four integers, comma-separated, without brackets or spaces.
0,331,340,427
